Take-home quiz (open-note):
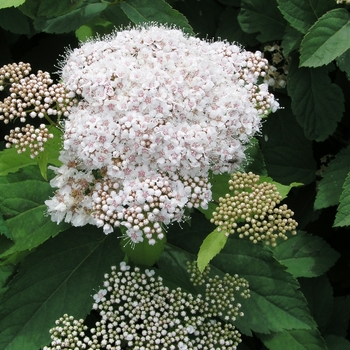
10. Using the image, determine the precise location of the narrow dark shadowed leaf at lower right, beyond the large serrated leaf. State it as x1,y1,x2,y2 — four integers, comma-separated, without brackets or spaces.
299,275,333,333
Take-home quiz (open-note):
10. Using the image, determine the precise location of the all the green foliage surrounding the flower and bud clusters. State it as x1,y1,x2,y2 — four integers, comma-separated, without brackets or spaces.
0,0,350,350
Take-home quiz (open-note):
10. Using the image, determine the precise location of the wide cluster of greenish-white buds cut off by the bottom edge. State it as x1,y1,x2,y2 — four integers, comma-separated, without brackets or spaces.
44,262,249,350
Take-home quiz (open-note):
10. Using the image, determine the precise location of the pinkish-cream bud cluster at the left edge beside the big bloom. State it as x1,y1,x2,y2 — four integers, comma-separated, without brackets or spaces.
0,62,77,158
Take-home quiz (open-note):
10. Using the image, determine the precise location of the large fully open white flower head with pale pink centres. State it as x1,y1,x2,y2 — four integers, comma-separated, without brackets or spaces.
46,25,278,244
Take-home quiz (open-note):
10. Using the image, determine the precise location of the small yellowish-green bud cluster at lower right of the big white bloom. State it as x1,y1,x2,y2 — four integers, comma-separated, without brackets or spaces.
211,172,298,246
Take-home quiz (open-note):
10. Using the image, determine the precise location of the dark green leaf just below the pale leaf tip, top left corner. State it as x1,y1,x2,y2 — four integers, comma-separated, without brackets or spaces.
0,7,32,35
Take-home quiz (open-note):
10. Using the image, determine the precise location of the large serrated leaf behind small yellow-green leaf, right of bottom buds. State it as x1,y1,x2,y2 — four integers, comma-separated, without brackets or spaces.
167,212,315,335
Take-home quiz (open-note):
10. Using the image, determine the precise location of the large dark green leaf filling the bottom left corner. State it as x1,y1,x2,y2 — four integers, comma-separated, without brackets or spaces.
0,226,123,350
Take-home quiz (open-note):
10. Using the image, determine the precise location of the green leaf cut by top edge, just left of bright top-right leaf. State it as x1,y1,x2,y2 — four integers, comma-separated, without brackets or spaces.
277,0,334,34
